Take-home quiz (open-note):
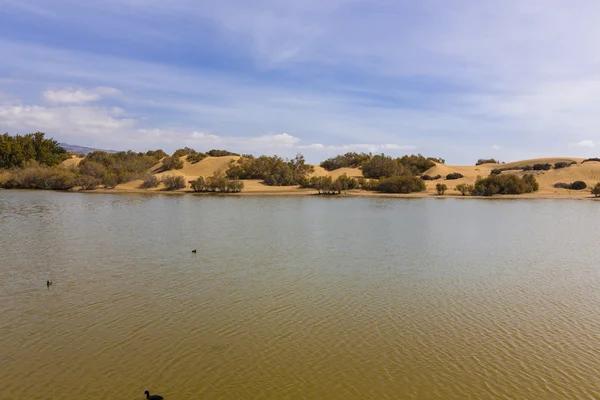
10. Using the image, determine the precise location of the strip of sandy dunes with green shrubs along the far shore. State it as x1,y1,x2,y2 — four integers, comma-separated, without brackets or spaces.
0,132,600,199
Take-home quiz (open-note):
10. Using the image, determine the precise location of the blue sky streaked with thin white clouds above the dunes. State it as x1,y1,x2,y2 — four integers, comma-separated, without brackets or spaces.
0,0,600,165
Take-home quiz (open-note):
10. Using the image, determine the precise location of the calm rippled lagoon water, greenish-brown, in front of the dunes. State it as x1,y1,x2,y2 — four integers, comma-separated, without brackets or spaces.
0,191,600,400
